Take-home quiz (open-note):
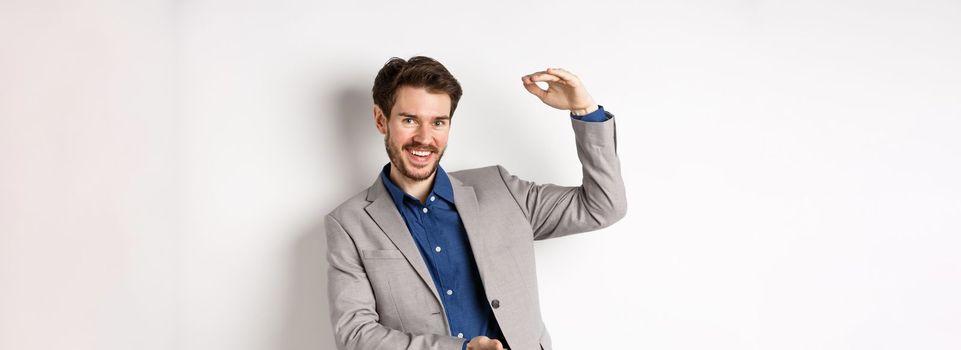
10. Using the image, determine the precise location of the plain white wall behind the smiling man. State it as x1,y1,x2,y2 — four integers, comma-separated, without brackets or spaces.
0,0,961,350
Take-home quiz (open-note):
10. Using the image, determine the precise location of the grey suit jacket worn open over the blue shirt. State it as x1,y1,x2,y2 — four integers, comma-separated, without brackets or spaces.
326,114,627,350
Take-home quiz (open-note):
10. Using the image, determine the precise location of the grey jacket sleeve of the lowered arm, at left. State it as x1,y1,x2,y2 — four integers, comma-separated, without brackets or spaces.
326,215,464,350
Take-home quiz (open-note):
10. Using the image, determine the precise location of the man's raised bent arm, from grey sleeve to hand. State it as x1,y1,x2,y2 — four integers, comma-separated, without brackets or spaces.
510,68,627,239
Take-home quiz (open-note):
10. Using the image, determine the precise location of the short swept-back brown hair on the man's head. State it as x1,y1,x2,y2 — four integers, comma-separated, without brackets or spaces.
372,56,464,118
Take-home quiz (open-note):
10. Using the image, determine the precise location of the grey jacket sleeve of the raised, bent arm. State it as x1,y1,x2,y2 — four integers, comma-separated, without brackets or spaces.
498,112,627,240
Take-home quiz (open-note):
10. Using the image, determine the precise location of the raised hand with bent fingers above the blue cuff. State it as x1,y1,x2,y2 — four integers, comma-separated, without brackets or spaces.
521,68,597,115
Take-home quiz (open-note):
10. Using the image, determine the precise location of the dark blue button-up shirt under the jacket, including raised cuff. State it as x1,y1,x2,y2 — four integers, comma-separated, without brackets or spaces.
381,106,608,349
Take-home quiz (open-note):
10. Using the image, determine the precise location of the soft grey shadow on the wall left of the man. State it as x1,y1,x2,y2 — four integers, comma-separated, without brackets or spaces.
278,85,379,350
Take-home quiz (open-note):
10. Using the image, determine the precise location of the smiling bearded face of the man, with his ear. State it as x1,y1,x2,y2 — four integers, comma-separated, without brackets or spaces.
374,86,451,181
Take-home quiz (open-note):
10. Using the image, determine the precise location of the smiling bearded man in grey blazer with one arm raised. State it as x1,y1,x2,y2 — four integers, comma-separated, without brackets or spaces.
326,56,626,350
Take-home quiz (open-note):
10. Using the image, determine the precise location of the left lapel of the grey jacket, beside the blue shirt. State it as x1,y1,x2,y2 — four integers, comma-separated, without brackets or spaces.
364,176,440,301
